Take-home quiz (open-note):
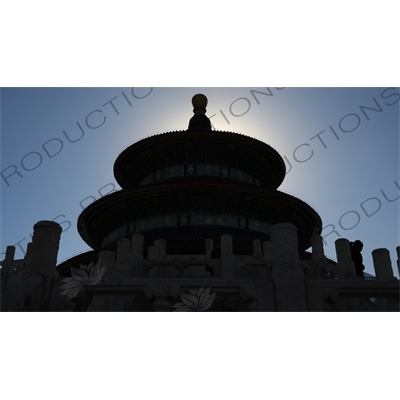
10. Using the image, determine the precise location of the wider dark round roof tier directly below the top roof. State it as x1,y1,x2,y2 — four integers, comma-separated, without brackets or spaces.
78,181,322,250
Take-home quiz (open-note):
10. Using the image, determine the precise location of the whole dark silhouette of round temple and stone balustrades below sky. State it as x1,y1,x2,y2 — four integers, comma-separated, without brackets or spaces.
1,94,400,311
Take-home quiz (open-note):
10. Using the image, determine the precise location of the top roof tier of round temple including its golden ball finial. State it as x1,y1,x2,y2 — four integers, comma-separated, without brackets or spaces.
114,94,286,189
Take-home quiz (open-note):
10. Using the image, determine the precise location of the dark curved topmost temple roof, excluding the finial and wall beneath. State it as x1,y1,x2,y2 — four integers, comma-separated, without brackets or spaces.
114,130,286,189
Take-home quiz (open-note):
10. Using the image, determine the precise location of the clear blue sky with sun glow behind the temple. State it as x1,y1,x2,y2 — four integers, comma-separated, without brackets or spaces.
0,87,400,277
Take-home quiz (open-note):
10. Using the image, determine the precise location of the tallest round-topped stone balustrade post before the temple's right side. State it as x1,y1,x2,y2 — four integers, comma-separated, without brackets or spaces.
271,223,307,311
